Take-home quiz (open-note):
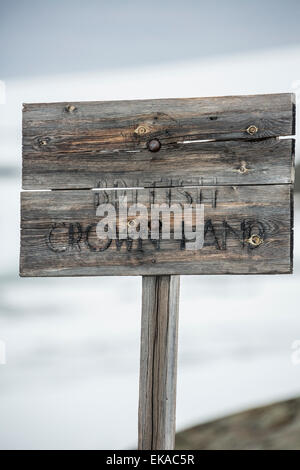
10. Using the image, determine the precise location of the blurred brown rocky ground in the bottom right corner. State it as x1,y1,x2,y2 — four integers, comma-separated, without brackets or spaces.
176,398,300,450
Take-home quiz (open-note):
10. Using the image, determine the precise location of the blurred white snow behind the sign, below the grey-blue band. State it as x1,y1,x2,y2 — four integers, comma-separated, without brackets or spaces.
0,1,300,449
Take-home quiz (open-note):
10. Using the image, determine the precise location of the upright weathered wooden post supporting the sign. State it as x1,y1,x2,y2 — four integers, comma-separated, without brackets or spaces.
138,276,180,450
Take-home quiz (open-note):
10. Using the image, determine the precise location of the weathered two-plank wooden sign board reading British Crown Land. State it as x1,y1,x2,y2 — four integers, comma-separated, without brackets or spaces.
20,94,295,276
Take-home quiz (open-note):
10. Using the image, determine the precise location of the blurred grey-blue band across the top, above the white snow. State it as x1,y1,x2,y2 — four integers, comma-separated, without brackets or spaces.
0,0,300,79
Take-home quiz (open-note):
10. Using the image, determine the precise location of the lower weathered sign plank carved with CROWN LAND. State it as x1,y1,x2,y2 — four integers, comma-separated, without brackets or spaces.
20,184,292,276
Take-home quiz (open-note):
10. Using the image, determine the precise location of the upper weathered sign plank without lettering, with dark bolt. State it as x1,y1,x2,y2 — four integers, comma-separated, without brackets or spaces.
23,93,295,189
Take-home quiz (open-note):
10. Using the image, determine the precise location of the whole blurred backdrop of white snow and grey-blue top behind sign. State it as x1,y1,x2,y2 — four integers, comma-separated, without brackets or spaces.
0,0,300,449
